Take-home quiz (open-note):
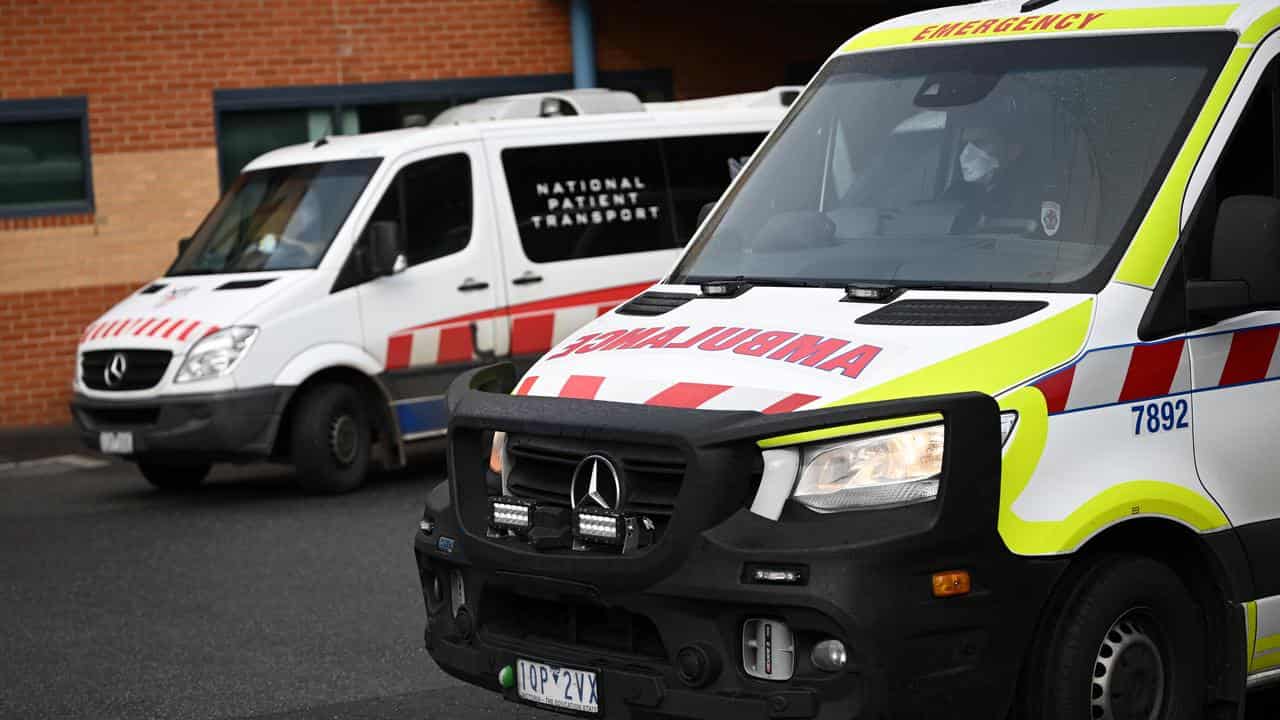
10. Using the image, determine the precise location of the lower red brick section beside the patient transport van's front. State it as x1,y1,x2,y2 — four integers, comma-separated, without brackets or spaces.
0,283,137,427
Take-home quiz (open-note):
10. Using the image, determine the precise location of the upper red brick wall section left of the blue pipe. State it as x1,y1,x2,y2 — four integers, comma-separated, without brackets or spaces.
0,0,572,154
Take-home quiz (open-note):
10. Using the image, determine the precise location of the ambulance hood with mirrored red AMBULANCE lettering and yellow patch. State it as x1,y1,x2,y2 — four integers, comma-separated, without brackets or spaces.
516,286,1094,413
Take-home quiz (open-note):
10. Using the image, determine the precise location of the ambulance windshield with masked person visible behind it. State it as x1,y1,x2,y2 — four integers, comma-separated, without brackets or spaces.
671,33,1234,292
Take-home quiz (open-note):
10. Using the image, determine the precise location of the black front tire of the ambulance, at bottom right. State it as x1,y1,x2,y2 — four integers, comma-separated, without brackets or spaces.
1015,555,1206,720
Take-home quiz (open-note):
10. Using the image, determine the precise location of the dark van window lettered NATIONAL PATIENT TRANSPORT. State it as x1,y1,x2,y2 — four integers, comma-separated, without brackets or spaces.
502,140,676,263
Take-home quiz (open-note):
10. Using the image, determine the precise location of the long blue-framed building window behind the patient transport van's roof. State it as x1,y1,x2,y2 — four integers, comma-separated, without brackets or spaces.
214,70,672,190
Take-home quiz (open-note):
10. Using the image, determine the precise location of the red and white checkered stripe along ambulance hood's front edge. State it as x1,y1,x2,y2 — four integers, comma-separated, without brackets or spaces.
516,375,818,415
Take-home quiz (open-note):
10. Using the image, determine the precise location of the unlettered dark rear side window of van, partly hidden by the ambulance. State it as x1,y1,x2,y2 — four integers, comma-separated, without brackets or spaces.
662,132,764,246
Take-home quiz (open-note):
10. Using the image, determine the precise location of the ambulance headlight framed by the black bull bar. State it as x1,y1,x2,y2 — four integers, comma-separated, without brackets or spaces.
792,413,1018,512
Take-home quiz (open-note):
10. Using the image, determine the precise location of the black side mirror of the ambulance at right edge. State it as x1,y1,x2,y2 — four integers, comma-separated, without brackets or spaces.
1187,195,1280,318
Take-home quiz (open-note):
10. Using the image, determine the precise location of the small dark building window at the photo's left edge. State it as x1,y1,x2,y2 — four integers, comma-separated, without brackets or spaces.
0,119,88,209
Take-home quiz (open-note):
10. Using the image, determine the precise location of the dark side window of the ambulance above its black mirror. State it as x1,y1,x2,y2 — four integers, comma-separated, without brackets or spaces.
1188,61,1280,279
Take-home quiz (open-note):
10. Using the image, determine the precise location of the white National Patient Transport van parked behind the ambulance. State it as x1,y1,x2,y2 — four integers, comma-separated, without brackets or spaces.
72,91,785,492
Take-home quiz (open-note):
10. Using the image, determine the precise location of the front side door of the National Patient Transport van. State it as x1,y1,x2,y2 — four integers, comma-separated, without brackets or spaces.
358,146,507,439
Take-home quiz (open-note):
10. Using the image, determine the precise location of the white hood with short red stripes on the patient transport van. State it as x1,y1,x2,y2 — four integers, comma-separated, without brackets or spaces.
81,272,303,350
